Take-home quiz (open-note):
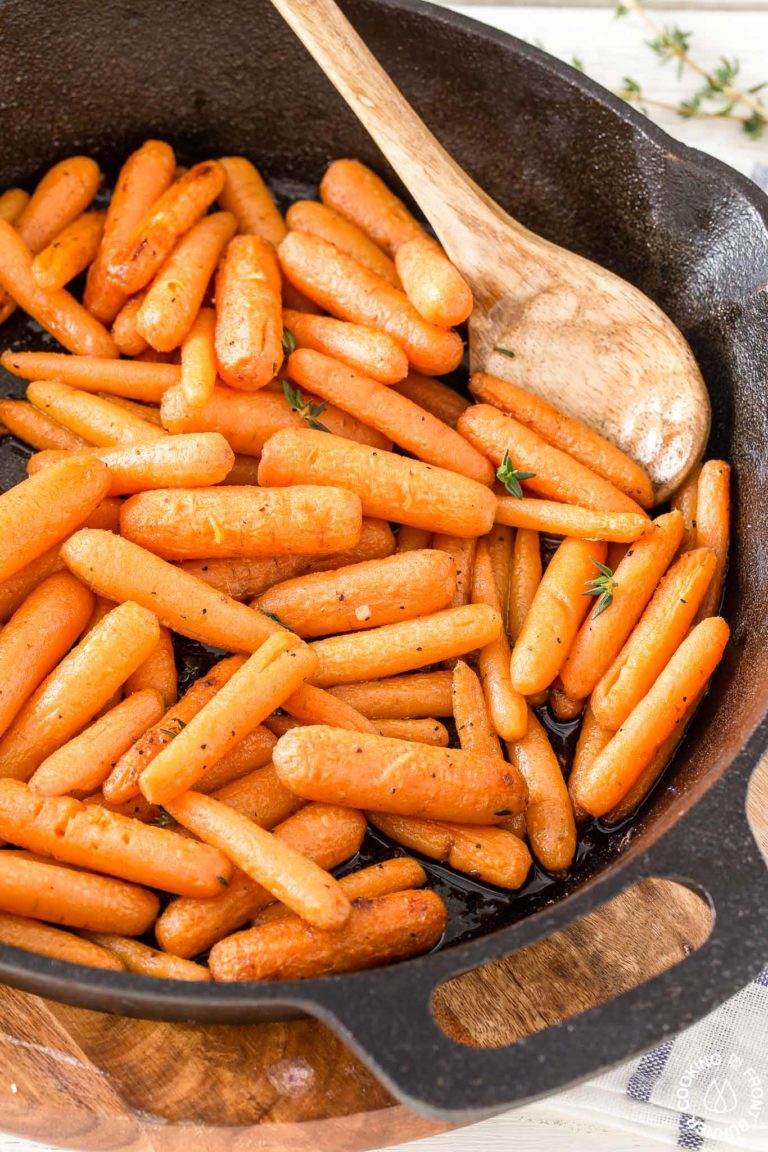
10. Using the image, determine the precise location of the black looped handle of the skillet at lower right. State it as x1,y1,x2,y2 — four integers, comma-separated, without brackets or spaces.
315,753,768,1121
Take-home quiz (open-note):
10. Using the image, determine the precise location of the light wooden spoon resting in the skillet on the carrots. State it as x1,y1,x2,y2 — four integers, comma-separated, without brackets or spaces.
272,0,710,502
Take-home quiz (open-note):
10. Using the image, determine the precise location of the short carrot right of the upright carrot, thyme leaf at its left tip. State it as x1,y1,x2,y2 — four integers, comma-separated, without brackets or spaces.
282,309,408,387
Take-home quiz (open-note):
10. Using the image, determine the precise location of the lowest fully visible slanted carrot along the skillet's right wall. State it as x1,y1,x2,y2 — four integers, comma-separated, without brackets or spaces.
573,616,729,815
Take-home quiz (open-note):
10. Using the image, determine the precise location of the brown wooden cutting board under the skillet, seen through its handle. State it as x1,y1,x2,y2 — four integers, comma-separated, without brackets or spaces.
0,760,768,1152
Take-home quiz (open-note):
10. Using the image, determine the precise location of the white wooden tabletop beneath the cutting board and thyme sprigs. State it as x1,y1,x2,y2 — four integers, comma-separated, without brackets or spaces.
0,0,768,1152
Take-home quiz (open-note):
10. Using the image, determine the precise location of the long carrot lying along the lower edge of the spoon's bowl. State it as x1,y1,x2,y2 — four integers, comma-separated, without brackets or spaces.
470,372,653,508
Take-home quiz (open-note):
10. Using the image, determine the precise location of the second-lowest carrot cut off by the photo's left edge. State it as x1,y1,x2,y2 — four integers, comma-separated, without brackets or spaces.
0,851,160,935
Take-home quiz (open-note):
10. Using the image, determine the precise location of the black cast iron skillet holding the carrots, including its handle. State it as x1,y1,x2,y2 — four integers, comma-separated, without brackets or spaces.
0,0,768,1119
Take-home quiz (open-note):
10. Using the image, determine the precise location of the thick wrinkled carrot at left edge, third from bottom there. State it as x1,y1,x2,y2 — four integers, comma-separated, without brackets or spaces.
0,780,231,896
